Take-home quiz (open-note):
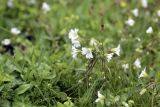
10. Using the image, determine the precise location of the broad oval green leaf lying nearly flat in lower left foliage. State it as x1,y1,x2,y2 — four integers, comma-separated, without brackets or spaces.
15,84,32,95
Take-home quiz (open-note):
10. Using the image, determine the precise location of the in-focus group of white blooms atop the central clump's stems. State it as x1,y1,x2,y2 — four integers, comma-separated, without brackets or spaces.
68,29,120,62
